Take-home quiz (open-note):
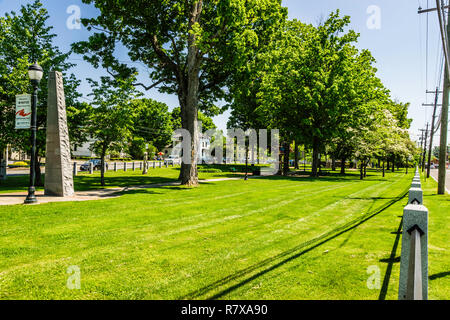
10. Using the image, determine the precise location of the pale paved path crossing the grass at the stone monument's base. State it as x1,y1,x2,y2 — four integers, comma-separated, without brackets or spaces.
0,178,242,206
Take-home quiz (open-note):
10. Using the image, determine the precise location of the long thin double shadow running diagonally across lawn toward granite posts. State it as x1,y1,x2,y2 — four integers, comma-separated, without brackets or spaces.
179,187,409,300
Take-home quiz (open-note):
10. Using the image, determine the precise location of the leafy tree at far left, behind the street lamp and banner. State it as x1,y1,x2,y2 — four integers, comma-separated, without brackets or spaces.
0,0,79,185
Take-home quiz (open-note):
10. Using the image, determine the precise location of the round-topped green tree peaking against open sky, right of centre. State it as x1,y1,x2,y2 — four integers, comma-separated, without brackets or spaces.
260,11,358,176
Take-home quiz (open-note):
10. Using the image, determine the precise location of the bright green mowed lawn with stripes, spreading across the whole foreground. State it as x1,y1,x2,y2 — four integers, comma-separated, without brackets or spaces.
0,171,450,299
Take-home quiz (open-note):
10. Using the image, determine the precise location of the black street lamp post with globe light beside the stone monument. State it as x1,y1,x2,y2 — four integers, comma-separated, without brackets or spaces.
24,63,44,204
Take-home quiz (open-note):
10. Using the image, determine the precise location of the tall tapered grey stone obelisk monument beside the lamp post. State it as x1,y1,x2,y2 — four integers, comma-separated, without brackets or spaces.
45,71,74,197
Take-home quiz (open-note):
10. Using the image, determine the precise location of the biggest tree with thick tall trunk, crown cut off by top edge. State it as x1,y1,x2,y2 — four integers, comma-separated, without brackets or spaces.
74,0,286,185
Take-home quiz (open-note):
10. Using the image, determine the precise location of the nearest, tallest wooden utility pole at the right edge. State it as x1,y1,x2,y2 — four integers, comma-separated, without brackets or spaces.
419,0,450,194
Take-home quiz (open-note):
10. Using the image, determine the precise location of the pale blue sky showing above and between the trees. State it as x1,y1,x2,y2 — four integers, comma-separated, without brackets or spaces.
0,0,441,144
